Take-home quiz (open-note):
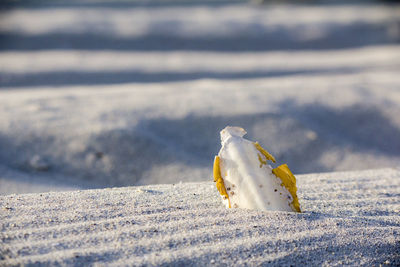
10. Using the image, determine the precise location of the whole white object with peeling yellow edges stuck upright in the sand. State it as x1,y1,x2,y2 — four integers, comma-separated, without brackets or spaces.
214,126,300,212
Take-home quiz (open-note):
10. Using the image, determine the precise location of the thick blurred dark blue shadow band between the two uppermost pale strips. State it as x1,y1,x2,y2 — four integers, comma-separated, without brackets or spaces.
0,22,396,52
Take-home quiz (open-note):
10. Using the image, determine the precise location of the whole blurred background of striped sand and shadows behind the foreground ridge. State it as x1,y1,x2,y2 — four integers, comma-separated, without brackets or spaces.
0,0,400,194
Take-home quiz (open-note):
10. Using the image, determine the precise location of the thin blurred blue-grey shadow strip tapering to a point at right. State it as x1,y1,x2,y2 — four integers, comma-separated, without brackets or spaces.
0,67,382,90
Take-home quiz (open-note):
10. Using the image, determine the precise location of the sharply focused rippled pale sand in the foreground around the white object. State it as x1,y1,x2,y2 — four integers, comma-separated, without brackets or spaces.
0,169,400,266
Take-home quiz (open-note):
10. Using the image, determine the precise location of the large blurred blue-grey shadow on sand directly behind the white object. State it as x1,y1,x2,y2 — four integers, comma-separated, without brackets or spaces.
0,102,400,187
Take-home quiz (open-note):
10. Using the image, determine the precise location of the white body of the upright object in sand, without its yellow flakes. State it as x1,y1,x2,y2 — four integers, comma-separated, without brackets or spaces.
218,126,293,211
